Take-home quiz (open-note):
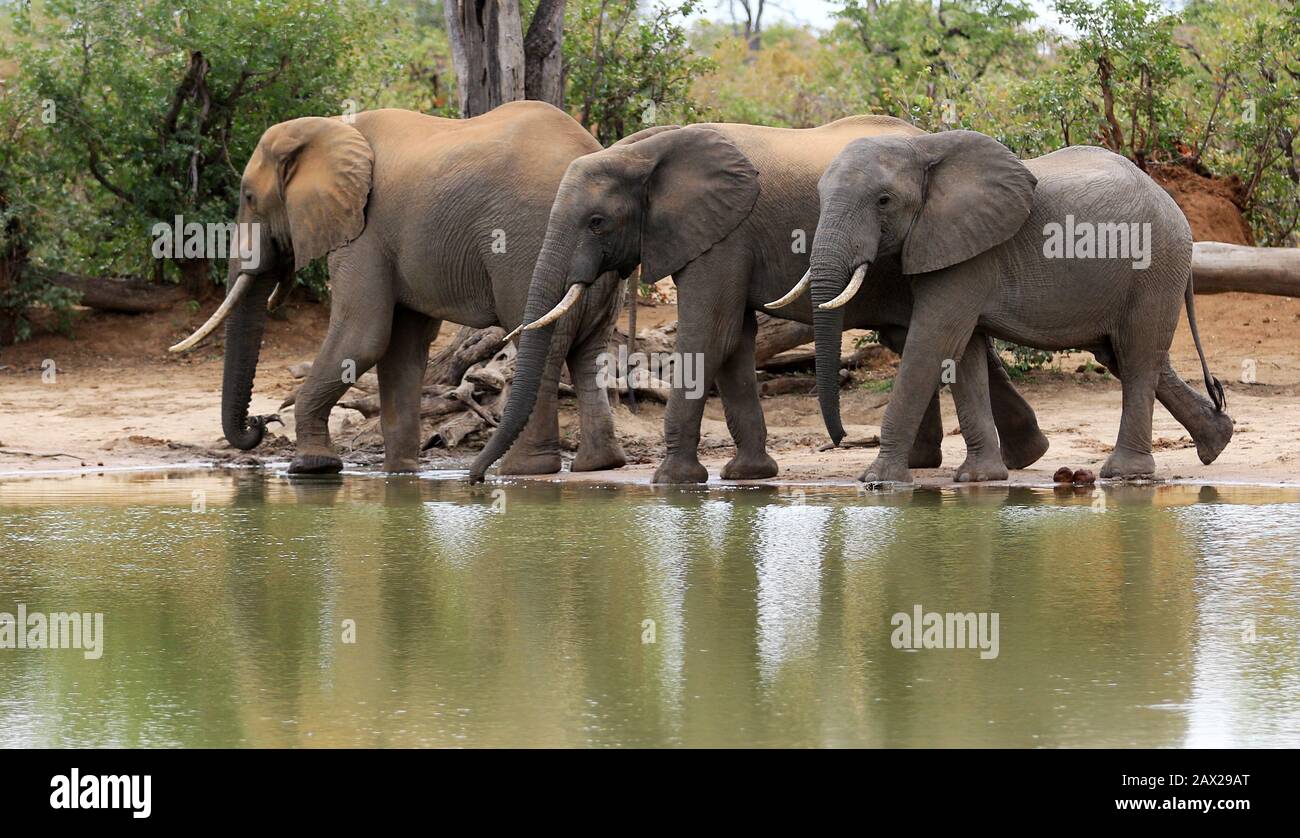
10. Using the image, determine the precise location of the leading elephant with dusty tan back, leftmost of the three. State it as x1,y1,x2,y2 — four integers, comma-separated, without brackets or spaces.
172,101,625,474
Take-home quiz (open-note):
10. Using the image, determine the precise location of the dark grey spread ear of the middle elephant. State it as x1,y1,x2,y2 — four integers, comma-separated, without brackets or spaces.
628,126,758,282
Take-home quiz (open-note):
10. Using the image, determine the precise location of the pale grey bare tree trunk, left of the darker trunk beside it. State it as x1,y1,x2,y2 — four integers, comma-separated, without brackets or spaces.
445,0,524,118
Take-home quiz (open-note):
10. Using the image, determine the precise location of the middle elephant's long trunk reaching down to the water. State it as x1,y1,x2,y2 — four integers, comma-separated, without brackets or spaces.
469,222,576,483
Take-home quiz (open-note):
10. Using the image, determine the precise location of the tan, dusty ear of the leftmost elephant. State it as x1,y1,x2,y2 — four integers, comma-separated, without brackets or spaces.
260,117,374,270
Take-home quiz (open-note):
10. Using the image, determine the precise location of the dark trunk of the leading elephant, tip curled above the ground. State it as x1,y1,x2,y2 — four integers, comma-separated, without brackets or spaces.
221,260,279,451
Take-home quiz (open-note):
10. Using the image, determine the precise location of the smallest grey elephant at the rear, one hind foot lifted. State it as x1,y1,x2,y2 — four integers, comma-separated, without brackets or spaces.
813,131,1232,483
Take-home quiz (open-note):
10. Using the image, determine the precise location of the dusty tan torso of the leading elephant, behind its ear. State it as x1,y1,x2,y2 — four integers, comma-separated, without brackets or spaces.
345,101,601,327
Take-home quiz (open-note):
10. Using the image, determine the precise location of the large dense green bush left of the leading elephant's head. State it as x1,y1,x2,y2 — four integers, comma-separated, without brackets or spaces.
13,0,405,283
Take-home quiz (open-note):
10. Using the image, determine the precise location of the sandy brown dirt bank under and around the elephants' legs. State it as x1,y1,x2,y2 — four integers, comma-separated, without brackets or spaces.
0,287,1300,485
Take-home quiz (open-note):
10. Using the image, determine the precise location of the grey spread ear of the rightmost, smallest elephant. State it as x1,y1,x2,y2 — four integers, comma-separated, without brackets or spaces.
902,131,1037,274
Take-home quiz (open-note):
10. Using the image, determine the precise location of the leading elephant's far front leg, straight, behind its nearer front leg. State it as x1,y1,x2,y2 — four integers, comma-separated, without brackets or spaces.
378,305,442,472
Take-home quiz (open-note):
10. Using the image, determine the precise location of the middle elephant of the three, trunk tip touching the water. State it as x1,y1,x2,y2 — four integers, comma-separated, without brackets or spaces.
471,116,1047,483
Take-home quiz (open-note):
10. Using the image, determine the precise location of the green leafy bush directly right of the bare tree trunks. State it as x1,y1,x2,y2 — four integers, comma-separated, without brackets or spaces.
564,0,712,146
